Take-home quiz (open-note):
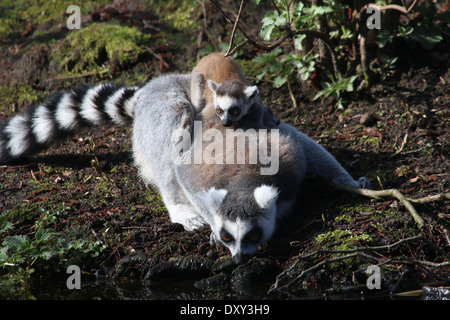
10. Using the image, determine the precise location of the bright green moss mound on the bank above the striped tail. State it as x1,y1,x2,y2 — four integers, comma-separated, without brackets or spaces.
51,22,150,74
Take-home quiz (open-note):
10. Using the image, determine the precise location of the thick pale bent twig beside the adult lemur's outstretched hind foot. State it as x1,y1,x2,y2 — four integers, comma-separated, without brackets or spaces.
335,184,425,229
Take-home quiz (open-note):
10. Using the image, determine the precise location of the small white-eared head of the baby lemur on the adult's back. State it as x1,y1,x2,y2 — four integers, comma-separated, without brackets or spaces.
208,80,259,127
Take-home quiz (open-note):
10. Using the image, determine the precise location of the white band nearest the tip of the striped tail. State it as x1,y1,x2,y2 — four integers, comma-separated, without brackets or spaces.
5,115,30,157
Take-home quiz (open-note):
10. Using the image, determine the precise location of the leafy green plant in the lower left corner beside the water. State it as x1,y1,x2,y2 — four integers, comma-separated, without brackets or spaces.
0,203,106,299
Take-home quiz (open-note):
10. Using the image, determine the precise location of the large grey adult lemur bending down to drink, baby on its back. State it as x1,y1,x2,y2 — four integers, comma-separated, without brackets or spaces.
0,56,368,263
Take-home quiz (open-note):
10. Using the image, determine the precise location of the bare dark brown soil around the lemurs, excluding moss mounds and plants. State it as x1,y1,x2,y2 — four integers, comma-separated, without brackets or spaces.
0,0,450,298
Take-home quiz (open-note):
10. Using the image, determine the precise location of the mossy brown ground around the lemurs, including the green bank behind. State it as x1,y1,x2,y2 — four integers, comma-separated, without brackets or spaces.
0,0,450,298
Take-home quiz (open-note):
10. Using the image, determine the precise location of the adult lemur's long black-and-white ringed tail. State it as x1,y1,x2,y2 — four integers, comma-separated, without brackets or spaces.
0,84,140,164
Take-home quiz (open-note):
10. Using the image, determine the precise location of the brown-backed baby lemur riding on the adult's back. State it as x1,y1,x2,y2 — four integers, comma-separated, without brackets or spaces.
191,52,279,129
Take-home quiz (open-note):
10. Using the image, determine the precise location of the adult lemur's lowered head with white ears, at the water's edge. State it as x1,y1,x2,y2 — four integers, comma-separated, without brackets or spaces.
202,185,278,264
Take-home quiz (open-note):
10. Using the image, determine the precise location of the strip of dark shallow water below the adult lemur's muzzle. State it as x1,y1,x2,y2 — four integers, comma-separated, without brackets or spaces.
27,279,440,300
